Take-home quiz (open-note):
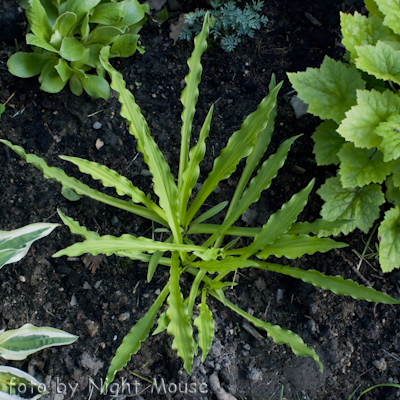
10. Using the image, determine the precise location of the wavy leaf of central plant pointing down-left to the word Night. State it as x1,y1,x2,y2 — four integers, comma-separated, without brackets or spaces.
101,285,169,393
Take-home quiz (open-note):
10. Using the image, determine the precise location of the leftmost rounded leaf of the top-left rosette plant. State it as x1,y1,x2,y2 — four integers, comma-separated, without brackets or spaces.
7,52,54,78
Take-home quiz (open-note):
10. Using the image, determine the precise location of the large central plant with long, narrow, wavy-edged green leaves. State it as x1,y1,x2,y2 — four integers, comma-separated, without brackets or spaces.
2,15,399,387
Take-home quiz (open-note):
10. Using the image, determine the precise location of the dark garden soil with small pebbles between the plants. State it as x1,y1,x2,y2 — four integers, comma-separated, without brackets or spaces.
0,0,400,400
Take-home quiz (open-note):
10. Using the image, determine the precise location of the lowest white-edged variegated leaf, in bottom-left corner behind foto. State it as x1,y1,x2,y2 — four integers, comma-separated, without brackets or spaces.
0,366,48,400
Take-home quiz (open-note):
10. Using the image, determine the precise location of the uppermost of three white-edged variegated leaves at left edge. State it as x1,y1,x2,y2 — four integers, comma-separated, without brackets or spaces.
0,223,60,268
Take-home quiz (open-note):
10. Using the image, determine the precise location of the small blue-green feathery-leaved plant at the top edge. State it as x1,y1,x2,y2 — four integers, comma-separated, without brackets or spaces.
179,0,268,53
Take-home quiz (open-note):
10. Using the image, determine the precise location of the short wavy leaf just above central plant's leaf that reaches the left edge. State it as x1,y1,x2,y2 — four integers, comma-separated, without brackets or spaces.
60,156,165,218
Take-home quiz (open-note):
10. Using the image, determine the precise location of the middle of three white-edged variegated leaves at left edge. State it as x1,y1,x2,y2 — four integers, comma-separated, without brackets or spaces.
0,324,78,360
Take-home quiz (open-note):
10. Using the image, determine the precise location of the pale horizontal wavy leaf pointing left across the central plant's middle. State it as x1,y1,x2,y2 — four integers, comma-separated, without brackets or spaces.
53,234,210,257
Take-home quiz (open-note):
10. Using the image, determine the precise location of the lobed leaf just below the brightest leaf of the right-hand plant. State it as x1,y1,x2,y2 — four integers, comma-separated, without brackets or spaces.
338,143,392,188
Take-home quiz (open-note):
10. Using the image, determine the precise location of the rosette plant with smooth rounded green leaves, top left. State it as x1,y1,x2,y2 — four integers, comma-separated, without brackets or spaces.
7,0,149,99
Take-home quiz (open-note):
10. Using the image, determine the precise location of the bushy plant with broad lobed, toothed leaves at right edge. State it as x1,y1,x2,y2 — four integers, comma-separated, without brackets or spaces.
288,0,400,272
